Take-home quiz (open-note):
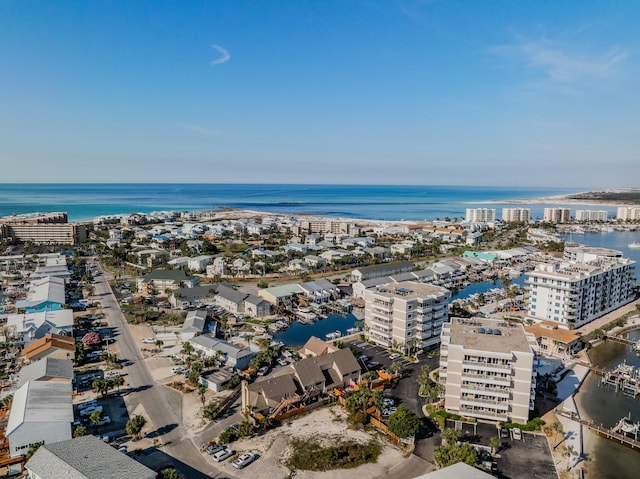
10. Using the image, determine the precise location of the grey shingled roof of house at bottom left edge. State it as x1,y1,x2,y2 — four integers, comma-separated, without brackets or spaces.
25,434,157,479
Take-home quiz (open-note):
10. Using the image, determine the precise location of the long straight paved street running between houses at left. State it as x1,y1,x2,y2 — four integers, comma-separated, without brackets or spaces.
89,260,218,479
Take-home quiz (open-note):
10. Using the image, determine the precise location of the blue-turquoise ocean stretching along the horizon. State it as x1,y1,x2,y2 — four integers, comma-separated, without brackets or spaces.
0,183,596,221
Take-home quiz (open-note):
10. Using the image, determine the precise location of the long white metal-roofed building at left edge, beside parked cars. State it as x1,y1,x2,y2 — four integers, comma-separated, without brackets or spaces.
5,381,73,457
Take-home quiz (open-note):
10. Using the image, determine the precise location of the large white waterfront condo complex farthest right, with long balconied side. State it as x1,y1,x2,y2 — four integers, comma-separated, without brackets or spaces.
527,245,635,328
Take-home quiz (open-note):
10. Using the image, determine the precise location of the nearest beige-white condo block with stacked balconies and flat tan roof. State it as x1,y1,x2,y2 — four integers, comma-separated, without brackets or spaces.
440,318,537,424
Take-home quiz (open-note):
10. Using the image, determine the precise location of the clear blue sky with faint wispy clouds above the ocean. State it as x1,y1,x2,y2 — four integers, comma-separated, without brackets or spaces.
0,0,640,190
